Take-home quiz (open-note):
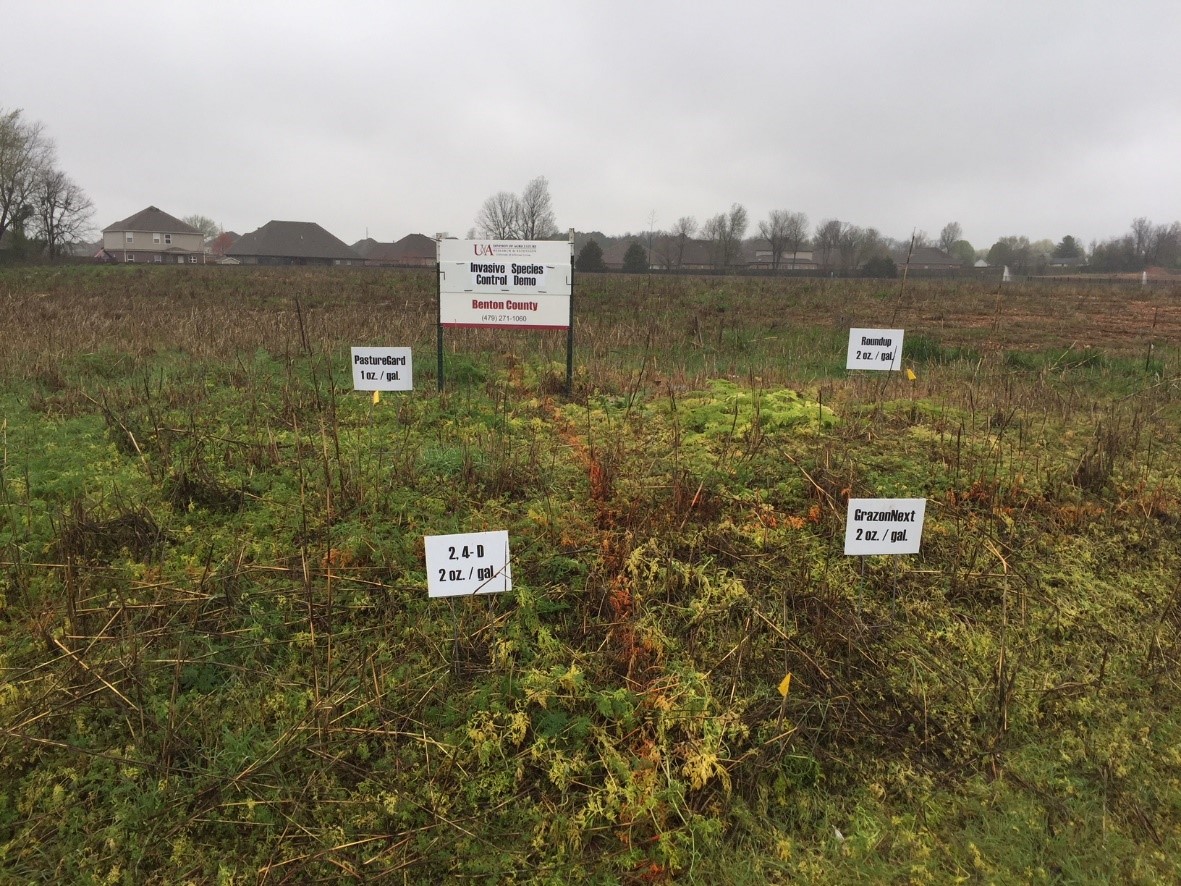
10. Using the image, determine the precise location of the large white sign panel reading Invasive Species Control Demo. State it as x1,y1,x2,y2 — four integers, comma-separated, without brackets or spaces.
438,240,573,330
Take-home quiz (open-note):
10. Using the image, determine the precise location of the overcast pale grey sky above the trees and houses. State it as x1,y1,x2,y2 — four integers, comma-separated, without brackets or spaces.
0,0,1181,248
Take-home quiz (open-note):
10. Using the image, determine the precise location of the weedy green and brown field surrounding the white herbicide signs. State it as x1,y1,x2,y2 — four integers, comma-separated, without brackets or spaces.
0,267,1181,884
